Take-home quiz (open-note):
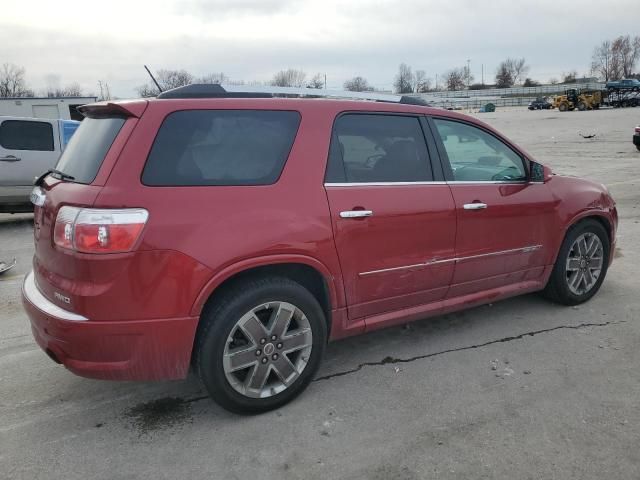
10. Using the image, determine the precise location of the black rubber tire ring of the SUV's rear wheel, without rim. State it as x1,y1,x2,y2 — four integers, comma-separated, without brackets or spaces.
194,277,327,414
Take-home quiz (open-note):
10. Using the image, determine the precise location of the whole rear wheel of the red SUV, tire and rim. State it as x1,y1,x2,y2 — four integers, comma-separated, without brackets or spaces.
195,277,327,413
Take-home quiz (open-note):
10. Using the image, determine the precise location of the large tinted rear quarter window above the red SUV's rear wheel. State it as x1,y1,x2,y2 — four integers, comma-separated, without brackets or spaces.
142,110,300,186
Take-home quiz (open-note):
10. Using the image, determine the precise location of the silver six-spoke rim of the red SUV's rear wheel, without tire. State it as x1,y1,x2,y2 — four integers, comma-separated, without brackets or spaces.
223,302,313,398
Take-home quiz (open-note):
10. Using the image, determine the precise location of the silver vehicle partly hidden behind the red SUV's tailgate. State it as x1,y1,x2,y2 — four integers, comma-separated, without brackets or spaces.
0,116,80,213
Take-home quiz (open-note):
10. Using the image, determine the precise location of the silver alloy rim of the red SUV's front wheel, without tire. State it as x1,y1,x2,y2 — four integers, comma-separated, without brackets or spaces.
566,232,604,295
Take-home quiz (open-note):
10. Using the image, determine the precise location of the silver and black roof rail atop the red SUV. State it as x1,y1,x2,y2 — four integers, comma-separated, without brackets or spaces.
157,83,429,106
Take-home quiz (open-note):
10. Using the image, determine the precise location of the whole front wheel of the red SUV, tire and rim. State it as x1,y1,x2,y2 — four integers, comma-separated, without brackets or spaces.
544,220,610,305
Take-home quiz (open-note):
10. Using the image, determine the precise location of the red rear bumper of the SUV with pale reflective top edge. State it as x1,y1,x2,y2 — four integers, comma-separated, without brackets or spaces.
22,272,198,380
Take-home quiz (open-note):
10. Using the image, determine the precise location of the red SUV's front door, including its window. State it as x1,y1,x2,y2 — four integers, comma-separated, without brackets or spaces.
433,118,554,297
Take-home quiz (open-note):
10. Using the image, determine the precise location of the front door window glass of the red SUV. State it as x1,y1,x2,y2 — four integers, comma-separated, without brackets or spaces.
434,118,527,182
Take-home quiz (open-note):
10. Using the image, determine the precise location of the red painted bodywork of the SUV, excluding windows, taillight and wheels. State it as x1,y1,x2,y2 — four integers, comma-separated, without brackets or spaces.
24,99,617,380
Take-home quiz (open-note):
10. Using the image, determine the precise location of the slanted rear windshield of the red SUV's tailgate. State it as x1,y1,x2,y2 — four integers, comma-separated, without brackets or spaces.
56,117,125,184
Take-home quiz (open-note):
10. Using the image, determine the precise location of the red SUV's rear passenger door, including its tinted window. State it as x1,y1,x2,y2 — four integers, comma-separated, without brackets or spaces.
325,113,456,320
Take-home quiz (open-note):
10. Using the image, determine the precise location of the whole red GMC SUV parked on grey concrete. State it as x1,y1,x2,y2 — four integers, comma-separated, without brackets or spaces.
23,86,618,412
